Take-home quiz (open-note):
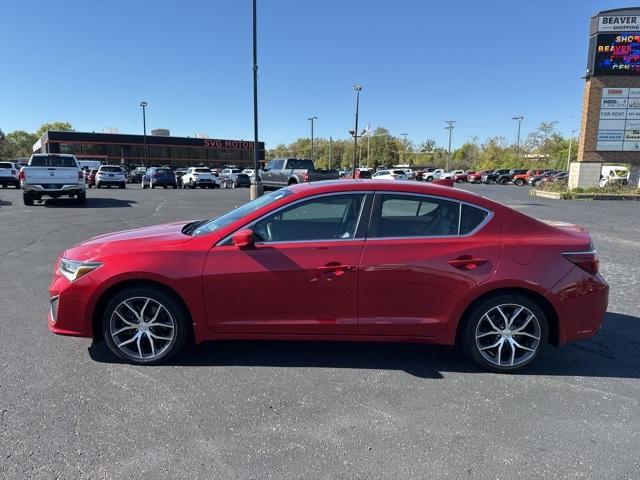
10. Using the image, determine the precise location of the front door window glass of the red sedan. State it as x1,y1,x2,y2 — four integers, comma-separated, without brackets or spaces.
253,194,364,242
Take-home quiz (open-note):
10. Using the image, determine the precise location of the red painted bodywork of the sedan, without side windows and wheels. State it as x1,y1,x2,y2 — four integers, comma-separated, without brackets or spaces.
49,180,608,345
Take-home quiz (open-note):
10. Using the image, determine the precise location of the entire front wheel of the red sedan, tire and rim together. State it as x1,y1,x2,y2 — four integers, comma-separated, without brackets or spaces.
102,286,192,365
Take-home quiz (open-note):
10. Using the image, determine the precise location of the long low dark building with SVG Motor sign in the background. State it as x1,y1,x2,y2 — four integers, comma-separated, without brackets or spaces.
33,129,265,168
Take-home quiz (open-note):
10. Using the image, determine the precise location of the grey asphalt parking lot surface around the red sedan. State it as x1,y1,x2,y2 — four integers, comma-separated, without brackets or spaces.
0,185,640,479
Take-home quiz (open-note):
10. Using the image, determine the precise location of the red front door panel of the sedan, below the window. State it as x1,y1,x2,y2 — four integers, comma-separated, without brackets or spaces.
204,240,364,335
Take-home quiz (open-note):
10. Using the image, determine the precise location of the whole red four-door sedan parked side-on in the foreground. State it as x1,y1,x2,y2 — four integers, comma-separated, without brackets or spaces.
49,180,609,372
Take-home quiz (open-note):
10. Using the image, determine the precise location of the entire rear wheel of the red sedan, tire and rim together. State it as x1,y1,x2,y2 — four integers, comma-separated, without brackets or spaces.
461,294,549,373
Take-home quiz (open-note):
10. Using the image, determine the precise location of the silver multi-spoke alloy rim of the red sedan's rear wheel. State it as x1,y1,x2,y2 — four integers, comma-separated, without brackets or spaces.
475,303,542,367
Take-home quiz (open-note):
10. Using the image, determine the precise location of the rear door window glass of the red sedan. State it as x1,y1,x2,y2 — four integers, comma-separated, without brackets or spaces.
372,194,461,237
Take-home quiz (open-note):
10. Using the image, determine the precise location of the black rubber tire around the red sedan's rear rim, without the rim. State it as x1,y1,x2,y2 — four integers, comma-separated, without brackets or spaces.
462,294,549,373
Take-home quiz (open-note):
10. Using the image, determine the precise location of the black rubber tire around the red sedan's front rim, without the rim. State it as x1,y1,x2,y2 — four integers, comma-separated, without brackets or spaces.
102,287,192,365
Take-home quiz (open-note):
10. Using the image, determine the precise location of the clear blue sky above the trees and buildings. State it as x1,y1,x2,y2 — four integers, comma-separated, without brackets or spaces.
0,0,627,147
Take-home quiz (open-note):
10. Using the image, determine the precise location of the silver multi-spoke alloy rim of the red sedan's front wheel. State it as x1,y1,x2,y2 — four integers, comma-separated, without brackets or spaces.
109,297,177,361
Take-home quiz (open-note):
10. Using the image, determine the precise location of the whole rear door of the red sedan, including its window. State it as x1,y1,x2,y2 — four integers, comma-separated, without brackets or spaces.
358,194,501,336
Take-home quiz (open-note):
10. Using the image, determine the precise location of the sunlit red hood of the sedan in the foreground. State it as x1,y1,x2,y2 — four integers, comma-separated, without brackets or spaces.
64,222,193,260
